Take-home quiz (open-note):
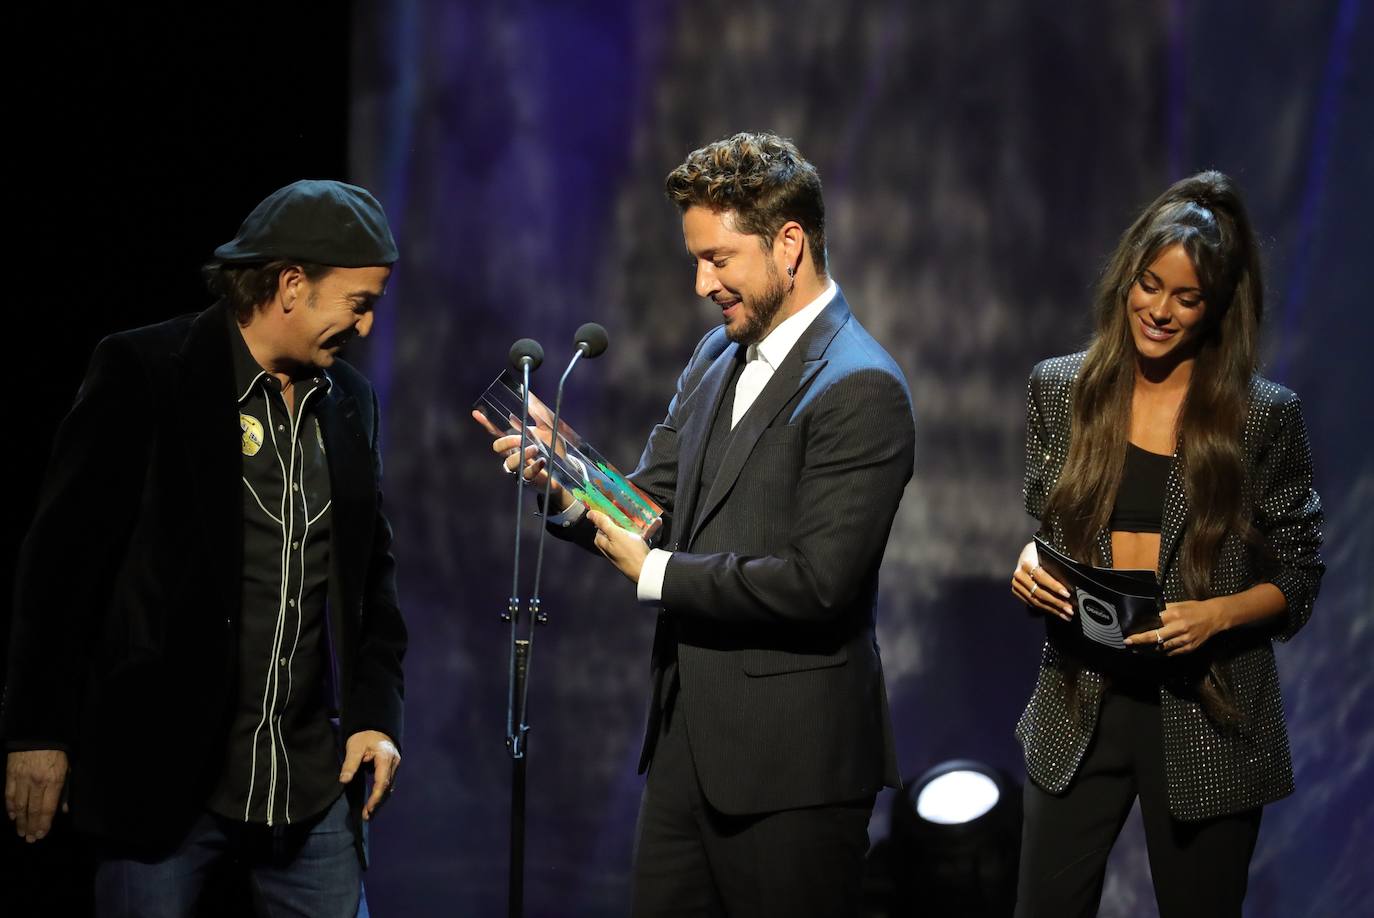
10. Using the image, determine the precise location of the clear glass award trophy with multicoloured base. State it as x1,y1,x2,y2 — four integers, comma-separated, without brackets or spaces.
473,370,664,544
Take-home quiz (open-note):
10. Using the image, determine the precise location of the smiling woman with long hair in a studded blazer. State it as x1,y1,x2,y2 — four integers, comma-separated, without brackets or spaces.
1011,172,1325,918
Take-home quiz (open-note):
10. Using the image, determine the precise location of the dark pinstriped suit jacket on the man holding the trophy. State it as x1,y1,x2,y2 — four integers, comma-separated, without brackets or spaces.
561,293,915,814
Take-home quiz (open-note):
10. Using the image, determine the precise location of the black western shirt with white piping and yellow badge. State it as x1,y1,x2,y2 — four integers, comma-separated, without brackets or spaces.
209,313,342,826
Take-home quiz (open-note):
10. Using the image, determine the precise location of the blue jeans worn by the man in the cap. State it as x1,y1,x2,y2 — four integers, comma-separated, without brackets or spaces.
95,794,367,918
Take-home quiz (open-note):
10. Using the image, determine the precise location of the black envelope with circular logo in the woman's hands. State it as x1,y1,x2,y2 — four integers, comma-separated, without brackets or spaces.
1035,536,1164,650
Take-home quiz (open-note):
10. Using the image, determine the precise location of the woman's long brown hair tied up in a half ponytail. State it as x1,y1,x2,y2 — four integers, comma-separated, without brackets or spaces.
1046,172,1264,599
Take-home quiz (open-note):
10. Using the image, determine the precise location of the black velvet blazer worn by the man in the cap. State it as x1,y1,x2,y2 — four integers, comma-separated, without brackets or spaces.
0,302,405,848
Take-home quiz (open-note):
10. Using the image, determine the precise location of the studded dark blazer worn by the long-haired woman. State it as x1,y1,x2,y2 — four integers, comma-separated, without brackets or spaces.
1017,353,1325,820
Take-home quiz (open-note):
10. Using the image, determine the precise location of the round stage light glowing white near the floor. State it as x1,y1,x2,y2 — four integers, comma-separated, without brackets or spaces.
886,759,1021,918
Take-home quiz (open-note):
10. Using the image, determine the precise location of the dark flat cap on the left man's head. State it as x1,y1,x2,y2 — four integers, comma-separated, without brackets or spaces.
214,179,400,268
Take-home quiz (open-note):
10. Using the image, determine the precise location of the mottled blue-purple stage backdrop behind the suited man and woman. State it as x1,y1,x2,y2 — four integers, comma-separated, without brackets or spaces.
332,0,1374,918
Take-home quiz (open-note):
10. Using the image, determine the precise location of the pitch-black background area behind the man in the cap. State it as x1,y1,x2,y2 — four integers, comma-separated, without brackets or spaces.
0,0,350,918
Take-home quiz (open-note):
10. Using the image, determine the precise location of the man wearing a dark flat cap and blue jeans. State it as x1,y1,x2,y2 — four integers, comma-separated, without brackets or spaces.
0,175,405,917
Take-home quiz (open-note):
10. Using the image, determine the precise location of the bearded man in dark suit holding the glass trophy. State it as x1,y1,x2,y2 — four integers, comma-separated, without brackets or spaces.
495,133,915,918
